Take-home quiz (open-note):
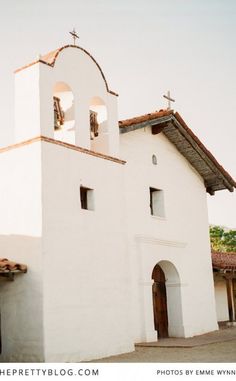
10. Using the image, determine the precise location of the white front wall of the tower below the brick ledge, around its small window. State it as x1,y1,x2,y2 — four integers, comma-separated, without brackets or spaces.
40,143,134,362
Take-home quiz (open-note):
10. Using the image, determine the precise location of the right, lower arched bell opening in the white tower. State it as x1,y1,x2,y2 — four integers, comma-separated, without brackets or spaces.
89,96,108,153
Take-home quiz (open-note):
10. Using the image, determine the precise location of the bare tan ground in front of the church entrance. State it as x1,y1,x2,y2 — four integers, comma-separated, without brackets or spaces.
91,327,236,363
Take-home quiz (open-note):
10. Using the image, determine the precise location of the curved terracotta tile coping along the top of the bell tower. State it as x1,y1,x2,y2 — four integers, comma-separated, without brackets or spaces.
15,45,118,96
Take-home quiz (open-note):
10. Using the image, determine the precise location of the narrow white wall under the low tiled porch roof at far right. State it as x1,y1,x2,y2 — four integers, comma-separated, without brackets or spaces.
214,276,229,321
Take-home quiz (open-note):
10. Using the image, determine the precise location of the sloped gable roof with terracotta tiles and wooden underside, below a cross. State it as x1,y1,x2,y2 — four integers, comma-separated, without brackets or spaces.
119,110,236,194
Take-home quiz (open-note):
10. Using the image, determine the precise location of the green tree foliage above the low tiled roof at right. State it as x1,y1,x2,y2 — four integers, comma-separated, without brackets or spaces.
210,226,236,252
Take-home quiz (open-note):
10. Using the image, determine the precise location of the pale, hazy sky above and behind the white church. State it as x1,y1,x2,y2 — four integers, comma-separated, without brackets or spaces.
0,0,236,228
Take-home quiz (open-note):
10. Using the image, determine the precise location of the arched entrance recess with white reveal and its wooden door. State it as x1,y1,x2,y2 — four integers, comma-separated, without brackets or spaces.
152,261,184,339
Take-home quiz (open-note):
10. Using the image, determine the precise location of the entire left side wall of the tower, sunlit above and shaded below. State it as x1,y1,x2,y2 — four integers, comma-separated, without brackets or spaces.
0,142,44,362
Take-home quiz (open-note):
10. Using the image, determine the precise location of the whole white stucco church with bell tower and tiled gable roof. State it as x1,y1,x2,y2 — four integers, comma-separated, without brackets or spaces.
0,45,236,362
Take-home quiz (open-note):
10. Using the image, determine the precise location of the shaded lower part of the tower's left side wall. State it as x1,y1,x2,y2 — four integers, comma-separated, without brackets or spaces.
0,235,44,362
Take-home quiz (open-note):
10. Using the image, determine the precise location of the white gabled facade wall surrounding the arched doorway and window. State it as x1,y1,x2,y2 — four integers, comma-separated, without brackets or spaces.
121,127,218,342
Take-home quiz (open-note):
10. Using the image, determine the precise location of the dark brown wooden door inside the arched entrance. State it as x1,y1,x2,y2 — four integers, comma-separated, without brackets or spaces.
152,265,168,339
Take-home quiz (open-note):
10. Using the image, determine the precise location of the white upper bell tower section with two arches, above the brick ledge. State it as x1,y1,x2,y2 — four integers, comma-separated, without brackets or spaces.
15,45,119,156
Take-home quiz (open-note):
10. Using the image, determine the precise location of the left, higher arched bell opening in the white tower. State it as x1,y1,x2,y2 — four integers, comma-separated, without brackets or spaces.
53,82,75,144
